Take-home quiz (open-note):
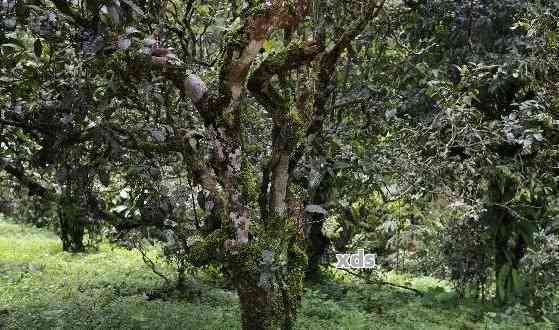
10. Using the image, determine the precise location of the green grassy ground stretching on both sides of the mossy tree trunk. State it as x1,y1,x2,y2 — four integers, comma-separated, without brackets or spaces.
0,220,553,330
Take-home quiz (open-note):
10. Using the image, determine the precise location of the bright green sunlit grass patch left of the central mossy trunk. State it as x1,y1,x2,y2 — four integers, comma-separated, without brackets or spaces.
0,219,239,329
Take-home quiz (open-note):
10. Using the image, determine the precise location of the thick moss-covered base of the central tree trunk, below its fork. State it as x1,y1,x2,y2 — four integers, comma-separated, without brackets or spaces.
231,227,307,329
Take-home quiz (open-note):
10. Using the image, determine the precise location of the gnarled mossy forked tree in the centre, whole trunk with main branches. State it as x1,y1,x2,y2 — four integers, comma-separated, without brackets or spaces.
142,0,384,329
